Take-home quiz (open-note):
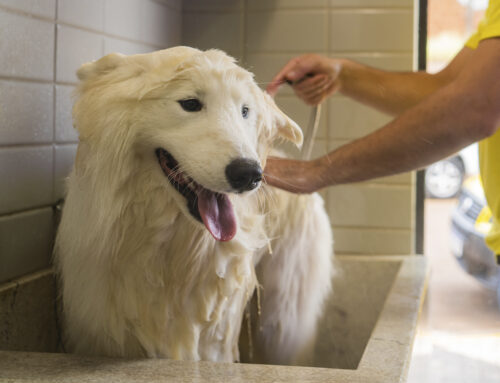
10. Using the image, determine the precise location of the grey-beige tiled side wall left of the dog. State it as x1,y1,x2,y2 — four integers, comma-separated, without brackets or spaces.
0,0,182,282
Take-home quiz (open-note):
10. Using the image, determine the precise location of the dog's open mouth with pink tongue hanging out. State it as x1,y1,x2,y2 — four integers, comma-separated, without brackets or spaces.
156,148,237,241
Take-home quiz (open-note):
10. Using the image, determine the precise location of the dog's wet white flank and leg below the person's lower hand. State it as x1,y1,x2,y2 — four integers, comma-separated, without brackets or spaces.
252,191,333,364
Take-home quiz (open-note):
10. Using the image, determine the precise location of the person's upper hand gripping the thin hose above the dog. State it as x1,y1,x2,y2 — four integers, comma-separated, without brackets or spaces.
266,54,343,105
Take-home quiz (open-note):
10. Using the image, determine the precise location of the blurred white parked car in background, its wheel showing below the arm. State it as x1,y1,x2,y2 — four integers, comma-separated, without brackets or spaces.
425,144,479,198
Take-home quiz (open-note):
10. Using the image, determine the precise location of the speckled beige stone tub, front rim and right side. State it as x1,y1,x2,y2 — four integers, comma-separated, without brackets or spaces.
0,256,427,383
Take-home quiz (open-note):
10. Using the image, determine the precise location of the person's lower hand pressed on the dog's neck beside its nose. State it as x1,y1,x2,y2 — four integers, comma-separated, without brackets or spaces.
264,157,327,194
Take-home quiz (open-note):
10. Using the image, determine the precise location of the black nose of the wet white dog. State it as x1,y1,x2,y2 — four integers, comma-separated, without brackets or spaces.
226,158,262,193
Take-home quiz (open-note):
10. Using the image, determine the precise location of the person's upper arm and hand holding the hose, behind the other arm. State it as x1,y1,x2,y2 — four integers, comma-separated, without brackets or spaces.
267,48,472,115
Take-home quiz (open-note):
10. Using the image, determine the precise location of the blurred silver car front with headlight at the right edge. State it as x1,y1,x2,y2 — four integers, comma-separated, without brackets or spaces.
451,175,500,298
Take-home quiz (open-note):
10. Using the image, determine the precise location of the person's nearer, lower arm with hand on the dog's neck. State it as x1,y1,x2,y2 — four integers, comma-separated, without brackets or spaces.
264,38,500,193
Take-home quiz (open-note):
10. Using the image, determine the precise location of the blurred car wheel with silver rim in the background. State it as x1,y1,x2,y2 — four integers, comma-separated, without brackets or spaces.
425,157,465,198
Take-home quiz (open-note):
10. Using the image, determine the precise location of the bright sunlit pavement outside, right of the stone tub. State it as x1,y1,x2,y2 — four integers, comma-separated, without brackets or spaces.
408,199,500,383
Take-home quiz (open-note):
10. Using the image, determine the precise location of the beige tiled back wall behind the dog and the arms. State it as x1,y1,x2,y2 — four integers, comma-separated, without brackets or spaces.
182,0,415,254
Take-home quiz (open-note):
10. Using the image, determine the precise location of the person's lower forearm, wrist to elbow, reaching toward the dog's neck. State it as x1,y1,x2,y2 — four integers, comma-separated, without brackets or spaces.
317,80,495,188
